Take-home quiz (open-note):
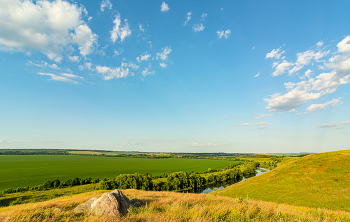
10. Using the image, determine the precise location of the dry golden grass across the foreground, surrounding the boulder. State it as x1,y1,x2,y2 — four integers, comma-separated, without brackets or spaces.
0,190,350,222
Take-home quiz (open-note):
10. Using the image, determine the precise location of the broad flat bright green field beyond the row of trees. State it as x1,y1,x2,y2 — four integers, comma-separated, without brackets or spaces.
0,155,237,191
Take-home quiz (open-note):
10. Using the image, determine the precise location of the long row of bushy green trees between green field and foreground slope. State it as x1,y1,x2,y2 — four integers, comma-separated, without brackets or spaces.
0,162,259,195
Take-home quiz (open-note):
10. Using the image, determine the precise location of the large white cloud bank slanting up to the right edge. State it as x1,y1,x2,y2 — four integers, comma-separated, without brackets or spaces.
264,36,350,112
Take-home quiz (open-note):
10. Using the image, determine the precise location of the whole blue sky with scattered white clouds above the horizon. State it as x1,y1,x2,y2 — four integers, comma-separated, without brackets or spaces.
0,0,350,153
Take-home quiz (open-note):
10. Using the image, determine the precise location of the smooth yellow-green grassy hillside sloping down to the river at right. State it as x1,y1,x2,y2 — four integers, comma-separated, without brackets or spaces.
215,150,350,212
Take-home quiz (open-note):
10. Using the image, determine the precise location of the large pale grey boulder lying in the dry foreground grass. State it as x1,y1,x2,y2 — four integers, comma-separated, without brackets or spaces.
73,189,144,217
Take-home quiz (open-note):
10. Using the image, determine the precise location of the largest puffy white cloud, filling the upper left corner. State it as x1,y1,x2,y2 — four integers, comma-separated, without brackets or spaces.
0,0,97,62
